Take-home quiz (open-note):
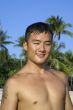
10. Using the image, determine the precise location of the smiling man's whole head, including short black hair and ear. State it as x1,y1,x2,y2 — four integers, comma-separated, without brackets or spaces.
24,22,53,64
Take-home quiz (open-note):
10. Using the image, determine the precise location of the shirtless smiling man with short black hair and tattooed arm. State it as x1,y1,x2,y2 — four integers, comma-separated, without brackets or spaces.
1,22,73,110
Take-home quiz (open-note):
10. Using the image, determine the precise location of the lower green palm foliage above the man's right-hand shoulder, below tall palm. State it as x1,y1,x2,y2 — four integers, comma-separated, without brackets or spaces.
48,41,73,76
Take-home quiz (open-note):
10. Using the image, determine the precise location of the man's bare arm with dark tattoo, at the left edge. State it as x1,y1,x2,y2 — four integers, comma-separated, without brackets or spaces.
0,79,17,110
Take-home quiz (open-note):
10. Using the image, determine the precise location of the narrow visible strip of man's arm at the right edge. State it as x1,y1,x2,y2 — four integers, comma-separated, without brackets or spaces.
65,78,73,110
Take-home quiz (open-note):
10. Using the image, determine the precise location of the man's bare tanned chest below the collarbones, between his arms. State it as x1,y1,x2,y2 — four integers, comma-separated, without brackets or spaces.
19,73,65,104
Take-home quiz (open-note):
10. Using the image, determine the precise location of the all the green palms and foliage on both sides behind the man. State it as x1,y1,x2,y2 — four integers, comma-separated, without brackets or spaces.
0,16,73,87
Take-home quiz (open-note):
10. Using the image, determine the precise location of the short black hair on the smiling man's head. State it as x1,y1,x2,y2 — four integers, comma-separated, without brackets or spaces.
25,22,53,42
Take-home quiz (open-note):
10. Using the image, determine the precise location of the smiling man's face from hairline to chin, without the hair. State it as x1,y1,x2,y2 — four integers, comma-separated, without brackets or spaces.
26,32,52,64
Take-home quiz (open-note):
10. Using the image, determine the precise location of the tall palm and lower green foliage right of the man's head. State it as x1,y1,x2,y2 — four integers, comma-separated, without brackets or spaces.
46,16,73,75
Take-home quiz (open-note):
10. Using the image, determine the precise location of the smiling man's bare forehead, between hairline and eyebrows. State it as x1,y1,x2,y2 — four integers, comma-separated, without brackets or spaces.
29,32,52,41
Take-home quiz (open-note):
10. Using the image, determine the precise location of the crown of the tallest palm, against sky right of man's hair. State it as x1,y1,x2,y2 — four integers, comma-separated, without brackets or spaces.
46,16,73,40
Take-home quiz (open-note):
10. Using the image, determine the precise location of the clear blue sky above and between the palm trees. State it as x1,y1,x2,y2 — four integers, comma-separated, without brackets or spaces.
0,0,73,57
